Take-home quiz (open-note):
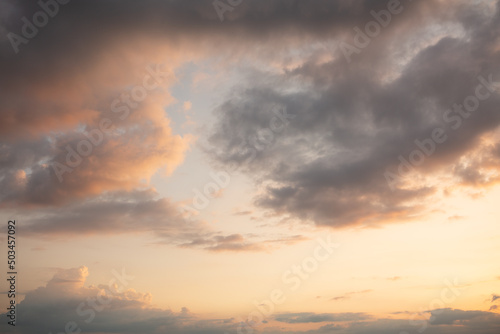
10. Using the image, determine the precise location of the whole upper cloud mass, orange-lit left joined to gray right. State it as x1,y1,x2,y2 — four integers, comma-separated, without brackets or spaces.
0,0,499,235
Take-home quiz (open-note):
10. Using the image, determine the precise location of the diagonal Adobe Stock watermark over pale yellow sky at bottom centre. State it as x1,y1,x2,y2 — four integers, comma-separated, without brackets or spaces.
231,235,340,334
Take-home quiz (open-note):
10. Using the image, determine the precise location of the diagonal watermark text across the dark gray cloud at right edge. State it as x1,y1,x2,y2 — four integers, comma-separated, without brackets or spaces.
384,74,500,191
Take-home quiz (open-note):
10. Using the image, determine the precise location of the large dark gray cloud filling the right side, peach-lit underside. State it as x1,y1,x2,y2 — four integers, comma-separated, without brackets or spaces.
207,3,500,227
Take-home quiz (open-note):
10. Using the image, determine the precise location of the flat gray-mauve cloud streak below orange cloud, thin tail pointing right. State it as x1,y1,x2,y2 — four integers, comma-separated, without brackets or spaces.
5,189,307,252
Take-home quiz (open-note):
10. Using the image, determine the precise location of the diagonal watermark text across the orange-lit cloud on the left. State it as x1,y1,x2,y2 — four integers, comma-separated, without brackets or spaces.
51,65,168,182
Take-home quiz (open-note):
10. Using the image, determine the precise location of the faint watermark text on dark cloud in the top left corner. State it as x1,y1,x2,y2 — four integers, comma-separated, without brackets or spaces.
7,0,70,54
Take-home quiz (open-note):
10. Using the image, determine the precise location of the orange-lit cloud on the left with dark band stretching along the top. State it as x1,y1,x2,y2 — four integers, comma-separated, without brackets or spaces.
0,0,452,237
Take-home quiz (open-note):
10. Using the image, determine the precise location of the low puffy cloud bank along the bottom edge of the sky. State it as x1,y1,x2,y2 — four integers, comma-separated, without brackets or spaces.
0,266,500,334
